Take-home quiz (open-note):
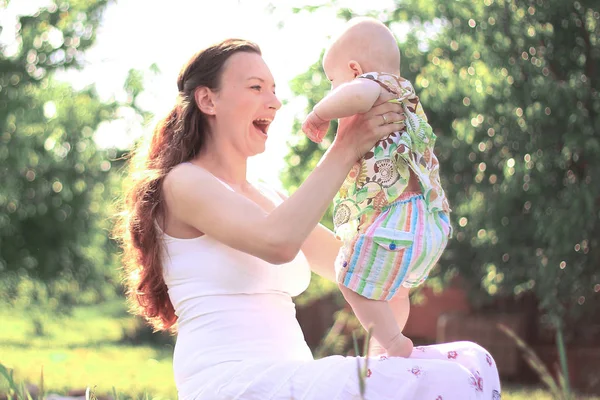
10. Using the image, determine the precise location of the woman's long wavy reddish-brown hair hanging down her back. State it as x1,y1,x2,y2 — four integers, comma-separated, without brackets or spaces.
115,39,261,331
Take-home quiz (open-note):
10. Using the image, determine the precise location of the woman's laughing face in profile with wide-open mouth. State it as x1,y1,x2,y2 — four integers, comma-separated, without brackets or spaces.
214,52,281,157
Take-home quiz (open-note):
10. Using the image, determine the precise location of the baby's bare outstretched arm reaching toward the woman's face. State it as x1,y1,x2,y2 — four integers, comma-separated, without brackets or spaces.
302,79,381,142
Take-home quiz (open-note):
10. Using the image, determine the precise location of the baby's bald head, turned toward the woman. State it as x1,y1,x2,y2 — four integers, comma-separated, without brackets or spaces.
323,17,400,81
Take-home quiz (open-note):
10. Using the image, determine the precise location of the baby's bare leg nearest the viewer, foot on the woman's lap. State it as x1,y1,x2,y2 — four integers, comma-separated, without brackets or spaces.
339,285,413,357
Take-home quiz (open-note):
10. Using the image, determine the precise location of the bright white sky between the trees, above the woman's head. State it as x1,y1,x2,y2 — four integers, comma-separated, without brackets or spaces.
0,0,394,186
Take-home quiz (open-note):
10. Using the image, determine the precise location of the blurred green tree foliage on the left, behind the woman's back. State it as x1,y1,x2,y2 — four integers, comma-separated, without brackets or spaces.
0,0,142,310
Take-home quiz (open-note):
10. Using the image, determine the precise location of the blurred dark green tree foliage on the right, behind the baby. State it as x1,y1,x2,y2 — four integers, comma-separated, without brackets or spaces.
282,0,600,340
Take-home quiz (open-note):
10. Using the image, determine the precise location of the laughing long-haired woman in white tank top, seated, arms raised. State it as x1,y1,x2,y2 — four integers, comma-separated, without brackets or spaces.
121,40,499,400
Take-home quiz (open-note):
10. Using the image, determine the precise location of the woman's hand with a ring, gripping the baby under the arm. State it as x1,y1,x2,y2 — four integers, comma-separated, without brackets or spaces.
332,102,405,161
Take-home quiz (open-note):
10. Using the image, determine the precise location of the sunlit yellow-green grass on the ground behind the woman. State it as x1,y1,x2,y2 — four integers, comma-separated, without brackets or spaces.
0,301,600,400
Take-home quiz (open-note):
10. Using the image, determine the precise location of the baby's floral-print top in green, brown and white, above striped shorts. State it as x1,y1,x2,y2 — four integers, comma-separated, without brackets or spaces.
334,72,450,241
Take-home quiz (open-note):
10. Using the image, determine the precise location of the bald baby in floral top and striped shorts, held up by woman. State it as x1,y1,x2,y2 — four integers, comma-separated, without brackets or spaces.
302,18,452,357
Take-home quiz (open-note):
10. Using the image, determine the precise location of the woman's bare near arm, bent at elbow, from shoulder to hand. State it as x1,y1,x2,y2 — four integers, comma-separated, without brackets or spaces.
163,103,404,264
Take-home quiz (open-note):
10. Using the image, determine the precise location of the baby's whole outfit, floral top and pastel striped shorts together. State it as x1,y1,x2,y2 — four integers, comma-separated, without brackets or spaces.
334,73,452,300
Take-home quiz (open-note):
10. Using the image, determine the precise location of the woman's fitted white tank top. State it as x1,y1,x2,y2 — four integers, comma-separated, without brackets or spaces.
159,177,312,387
